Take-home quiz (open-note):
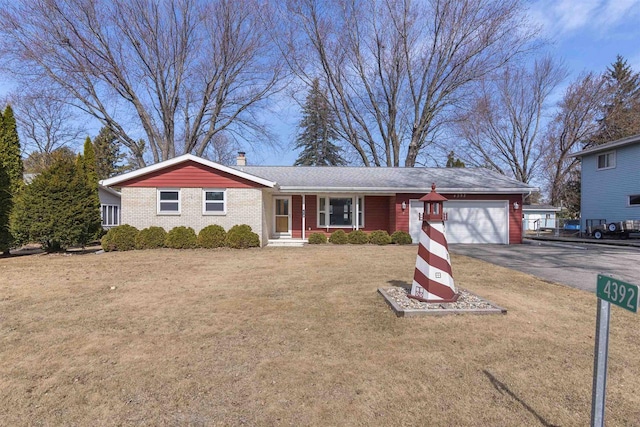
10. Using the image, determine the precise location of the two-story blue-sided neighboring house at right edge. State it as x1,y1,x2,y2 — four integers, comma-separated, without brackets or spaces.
574,135,640,230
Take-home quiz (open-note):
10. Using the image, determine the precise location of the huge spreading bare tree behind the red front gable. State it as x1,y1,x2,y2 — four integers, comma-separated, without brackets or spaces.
0,0,283,166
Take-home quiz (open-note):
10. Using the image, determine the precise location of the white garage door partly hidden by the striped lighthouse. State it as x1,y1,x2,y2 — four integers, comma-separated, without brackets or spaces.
409,200,509,244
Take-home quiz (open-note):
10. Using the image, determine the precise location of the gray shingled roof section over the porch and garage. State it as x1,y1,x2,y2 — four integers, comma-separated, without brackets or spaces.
234,166,537,193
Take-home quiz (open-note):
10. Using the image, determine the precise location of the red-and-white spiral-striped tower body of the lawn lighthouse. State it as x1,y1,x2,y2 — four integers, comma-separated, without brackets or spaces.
409,221,458,302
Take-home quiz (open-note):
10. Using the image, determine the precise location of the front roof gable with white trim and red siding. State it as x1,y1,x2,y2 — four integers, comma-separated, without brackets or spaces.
100,154,276,188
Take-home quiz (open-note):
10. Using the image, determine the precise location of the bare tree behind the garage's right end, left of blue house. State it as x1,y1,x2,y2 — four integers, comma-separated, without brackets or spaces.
456,57,566,183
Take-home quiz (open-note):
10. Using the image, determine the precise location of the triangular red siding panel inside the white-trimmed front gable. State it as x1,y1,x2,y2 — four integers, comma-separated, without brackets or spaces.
120,161,264,188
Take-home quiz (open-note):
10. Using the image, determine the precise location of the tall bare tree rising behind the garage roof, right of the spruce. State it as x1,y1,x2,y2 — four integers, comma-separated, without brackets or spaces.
287,0,534,166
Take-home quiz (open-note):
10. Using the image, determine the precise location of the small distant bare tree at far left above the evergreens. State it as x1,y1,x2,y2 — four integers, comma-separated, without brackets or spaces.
7,89,86,154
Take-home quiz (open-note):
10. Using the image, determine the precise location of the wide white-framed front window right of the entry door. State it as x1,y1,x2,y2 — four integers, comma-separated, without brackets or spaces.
318,196,364,228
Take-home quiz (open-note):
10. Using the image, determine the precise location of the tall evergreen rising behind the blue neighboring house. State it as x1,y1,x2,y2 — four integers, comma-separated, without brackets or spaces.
588,55,640,146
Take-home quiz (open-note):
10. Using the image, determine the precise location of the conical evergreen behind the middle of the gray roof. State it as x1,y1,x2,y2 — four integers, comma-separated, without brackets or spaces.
294,79,346,166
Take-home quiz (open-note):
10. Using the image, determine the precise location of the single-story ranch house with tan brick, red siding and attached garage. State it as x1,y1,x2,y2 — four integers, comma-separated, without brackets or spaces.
101,154,536,245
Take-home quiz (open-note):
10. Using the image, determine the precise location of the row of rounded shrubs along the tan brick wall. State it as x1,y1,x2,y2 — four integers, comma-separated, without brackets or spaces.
101,224,260,252
